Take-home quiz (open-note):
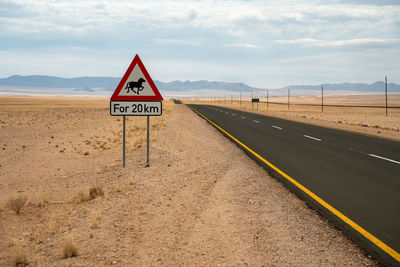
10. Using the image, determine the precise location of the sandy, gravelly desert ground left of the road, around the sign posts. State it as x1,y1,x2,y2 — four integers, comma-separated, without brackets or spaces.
0,97,376,266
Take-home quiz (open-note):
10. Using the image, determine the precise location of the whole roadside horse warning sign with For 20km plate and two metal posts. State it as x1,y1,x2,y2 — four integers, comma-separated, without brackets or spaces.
110,55,163,167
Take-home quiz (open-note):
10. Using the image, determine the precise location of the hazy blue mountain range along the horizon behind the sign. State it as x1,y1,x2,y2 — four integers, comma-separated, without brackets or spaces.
0,75,400,96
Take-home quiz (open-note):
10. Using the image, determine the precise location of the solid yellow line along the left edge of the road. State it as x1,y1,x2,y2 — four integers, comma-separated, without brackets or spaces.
191,107,400,262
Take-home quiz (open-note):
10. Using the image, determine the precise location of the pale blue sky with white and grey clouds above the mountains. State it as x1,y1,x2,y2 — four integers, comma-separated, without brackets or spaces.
0,0,400,88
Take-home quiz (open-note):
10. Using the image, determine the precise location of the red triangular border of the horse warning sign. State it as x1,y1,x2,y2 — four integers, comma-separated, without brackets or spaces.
110,54,164,101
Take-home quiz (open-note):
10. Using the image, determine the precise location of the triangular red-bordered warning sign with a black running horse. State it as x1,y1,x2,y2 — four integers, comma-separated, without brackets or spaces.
110,55,163,101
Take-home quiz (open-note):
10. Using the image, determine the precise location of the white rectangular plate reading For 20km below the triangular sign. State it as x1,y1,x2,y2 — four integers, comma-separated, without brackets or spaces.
110,101,162,116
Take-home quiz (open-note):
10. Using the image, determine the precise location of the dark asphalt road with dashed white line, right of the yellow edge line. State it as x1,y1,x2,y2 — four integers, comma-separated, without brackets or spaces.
191,105,400,264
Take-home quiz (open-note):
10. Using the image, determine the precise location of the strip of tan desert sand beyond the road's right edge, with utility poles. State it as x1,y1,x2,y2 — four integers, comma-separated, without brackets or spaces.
184,94,400,141
